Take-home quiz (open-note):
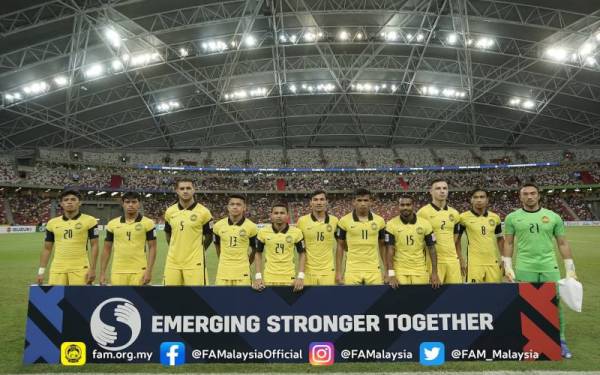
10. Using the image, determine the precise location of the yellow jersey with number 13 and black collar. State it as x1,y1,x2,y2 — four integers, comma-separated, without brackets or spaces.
213,217,258,279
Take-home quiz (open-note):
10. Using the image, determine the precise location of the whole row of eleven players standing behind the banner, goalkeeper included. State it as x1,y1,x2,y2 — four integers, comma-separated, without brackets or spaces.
37,179,577,358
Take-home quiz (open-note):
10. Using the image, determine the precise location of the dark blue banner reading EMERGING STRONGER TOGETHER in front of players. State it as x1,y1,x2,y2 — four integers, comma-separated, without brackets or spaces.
23,283,560,365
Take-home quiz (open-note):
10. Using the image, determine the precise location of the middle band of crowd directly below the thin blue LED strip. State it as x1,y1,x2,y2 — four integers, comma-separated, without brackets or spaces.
0,163,600,192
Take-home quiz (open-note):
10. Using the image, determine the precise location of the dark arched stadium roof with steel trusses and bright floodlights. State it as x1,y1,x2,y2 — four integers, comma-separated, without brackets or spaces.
0,0,600,151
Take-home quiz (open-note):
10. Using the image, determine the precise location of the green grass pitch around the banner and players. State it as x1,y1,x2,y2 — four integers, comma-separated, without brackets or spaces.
0,227,600,373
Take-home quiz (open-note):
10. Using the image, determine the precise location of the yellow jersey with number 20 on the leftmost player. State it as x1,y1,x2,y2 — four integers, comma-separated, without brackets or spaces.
46,213,98,273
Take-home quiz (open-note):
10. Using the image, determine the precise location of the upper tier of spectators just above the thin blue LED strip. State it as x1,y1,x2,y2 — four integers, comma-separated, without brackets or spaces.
32,147,600,168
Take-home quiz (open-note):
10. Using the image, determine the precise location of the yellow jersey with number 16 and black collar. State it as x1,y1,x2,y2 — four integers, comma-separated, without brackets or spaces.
296,214,338,275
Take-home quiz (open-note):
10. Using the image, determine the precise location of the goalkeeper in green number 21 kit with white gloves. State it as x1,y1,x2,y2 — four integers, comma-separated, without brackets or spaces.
502,184,577,359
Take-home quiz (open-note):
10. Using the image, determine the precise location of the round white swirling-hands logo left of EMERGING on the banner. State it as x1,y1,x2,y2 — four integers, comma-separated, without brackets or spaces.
90,297,142,351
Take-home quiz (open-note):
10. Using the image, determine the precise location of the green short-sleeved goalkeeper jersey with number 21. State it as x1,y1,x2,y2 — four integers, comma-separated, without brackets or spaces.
504,208,565,272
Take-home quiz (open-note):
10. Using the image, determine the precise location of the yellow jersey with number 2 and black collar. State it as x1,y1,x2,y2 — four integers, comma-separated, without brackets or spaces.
417,203,460,263
